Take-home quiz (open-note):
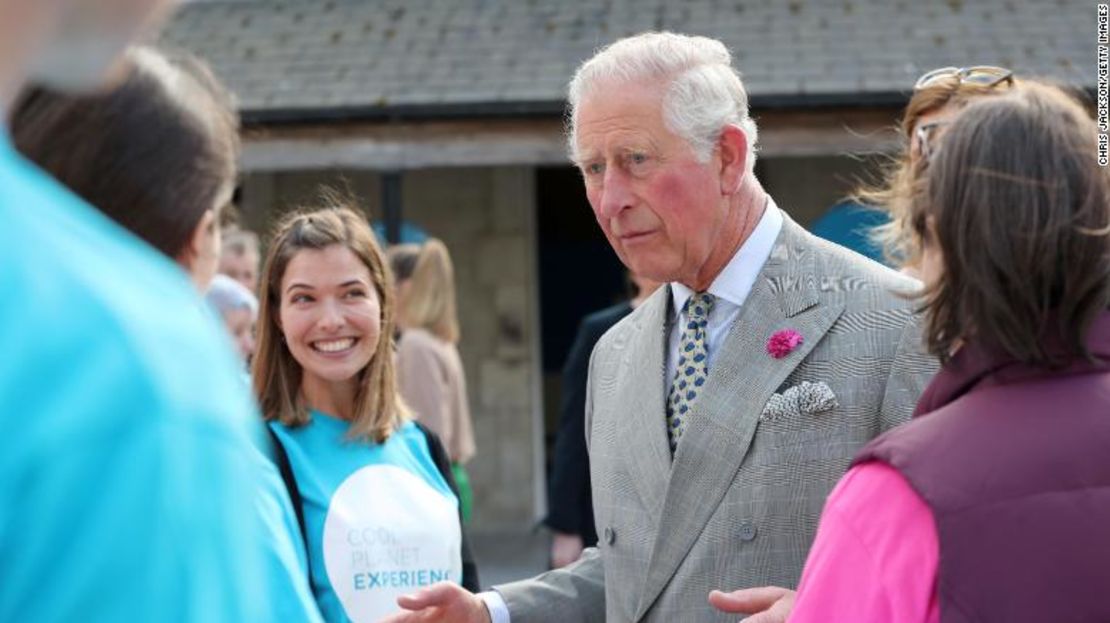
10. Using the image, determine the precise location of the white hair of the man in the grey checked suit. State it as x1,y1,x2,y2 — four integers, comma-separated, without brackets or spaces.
567,32,758,171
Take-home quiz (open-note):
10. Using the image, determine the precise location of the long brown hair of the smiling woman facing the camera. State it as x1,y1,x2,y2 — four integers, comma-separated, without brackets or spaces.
251,198,410,443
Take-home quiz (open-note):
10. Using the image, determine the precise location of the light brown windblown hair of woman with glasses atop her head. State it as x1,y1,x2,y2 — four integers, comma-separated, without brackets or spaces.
854,76,1017,267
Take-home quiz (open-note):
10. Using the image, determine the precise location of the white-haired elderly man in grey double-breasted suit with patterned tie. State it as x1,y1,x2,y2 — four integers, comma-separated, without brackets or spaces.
393,33,935,623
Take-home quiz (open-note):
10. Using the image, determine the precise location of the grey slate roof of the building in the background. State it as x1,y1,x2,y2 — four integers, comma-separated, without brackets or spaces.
162,0,1096,120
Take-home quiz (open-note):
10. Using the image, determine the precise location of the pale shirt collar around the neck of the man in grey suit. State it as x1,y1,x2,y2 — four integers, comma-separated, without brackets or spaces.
670,197,783,315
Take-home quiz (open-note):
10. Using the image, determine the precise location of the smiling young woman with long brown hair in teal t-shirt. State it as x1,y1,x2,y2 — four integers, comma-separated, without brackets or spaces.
253,198,477,622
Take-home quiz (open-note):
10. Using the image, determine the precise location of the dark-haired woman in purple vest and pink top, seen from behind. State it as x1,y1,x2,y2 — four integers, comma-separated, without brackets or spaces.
718,82,1110,623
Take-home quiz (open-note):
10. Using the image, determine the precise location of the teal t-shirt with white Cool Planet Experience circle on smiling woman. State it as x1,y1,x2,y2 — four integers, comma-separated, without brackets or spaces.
270,411,462,623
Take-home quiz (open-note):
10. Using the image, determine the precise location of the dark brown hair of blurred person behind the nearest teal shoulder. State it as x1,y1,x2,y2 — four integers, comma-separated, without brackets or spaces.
11,48,239,258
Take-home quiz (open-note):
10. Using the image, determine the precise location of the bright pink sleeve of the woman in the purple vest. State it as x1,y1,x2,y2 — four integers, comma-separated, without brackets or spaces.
790,462,940,623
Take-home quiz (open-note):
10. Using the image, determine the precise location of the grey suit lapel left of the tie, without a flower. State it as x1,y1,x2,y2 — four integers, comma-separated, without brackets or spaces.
614,287,670,518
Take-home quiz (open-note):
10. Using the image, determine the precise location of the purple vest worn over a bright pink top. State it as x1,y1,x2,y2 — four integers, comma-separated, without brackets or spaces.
855,314,1110,623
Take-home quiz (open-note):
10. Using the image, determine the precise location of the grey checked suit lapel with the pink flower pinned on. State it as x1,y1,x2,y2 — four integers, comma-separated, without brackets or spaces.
637,214,842,617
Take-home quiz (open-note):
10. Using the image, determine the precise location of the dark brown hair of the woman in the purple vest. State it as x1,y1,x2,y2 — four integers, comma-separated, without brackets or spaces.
914,82,1110,366
